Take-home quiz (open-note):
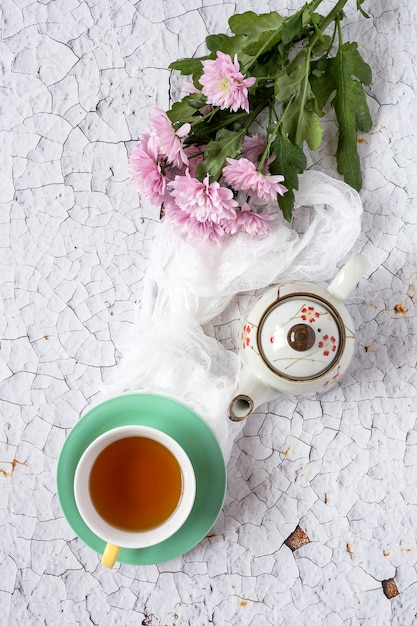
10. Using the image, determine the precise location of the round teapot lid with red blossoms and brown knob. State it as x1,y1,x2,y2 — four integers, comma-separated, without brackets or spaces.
258,293,346,381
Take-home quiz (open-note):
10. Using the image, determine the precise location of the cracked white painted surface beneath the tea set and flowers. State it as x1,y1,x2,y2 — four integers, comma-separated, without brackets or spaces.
0,0,417,626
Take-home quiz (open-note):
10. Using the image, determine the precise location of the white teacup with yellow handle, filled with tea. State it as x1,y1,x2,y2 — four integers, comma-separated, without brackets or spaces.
74,425,196,567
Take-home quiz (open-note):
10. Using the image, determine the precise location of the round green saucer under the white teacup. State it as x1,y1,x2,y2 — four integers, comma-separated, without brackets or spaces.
57,393,226,565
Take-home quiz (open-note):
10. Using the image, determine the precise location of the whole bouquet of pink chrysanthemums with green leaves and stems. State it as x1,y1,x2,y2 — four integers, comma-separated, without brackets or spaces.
130,0,372,241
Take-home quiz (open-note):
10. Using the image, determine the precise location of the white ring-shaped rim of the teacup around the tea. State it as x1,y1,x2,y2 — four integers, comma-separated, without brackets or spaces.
74,424,196,548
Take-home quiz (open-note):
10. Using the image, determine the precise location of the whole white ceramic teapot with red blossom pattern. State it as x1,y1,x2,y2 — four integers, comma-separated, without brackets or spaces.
228,254,368,422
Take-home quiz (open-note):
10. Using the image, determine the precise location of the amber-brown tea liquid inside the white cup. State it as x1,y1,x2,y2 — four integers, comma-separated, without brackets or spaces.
89,436,182,531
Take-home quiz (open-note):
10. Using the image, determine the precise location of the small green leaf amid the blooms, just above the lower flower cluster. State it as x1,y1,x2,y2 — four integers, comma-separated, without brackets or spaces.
197,129,245,180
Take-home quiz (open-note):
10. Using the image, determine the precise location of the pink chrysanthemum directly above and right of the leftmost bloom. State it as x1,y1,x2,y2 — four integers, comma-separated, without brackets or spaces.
149,108,191,168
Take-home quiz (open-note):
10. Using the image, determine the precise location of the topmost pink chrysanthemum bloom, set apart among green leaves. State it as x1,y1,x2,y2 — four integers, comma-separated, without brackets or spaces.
199,51,256,113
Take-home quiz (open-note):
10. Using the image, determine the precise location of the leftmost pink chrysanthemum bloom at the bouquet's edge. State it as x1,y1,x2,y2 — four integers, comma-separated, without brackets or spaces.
130,134,169,204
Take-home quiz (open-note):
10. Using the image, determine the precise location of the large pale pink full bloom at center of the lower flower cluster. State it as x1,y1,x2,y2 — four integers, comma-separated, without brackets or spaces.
170,172,238,224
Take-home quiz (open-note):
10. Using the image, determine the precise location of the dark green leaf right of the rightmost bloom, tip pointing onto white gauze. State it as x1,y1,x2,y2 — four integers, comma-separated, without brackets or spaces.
269,134,307,221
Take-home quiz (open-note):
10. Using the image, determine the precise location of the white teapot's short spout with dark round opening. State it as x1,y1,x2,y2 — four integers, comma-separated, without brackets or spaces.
227,367,279,422
